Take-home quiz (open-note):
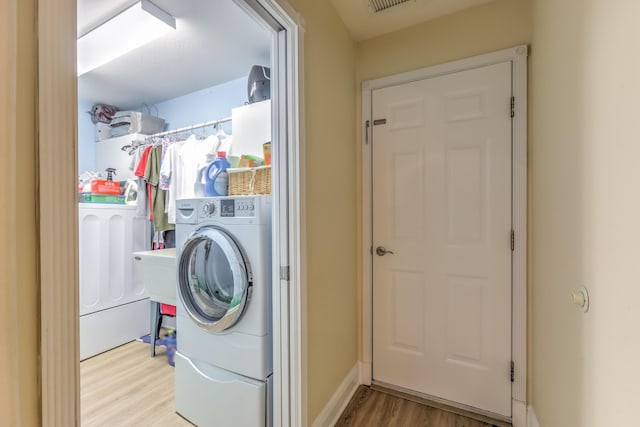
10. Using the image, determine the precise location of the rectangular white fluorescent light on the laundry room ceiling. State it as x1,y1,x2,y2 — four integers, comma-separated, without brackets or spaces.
78,0,176,76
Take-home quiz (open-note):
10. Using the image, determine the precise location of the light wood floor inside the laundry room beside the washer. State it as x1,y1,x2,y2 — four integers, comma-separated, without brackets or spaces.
80,341,192,427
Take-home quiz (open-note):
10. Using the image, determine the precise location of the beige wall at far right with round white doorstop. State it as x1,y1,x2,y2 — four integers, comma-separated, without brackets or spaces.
531,0,640,427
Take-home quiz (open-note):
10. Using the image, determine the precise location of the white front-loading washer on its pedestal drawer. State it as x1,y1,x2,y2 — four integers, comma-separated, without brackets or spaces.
175,196,273,427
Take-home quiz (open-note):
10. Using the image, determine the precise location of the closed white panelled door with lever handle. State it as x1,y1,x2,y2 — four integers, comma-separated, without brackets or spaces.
372,62,512,417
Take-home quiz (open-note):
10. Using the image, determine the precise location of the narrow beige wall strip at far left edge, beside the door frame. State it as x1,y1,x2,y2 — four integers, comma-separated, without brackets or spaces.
0,0,40,426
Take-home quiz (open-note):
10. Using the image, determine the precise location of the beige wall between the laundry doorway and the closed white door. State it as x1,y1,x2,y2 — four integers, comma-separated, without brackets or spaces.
290,0,357,424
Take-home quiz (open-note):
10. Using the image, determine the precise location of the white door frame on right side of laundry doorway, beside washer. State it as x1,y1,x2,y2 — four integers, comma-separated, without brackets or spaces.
244,0,307,427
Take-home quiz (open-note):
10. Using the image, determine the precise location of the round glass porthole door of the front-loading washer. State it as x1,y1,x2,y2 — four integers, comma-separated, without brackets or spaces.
178,226,250,332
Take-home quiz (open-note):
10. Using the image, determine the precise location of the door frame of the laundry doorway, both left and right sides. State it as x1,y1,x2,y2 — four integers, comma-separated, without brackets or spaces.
36,0,307,426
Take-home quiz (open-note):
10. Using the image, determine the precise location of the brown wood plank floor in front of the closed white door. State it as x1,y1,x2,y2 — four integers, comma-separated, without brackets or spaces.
335,386,508,427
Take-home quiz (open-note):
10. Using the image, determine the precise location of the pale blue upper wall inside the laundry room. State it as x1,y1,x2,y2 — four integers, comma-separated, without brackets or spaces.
78,77,247,173
